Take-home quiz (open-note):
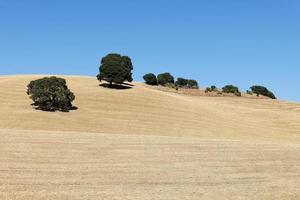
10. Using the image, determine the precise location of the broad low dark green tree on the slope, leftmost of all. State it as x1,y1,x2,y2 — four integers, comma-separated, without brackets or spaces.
27,76,75,112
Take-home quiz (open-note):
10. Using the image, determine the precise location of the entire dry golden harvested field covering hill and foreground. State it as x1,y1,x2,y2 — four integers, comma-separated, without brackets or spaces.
0,76,300,200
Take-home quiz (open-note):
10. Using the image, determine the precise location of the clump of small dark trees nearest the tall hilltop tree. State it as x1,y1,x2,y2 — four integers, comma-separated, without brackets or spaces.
143,72,199,88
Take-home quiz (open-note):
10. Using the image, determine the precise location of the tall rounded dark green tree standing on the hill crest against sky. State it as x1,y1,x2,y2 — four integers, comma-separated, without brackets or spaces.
97,54,133,84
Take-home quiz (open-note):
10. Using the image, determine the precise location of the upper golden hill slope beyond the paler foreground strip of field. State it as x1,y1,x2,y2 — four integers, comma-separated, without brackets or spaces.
0,76,300,142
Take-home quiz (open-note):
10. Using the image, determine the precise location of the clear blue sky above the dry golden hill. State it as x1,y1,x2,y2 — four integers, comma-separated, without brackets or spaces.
0,0,300,102
